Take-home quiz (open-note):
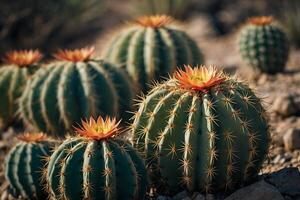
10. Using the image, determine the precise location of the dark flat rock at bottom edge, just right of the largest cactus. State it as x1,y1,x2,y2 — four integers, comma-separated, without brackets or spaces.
225,180,284,200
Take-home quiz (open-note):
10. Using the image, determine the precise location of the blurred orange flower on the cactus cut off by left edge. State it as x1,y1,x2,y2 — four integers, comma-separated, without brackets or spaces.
3,50,43,67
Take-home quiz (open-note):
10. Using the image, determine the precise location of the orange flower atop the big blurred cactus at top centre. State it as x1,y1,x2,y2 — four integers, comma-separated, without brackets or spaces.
134,15,173,28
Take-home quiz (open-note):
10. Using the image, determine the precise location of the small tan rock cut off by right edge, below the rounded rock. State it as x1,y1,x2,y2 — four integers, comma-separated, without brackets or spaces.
283,128,300,151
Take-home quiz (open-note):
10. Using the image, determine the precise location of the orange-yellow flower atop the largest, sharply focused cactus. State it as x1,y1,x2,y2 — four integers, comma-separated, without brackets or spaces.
174,66,227,93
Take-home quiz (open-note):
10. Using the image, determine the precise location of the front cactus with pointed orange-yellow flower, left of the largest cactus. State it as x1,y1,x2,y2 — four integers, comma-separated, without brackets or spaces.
46,117,147,200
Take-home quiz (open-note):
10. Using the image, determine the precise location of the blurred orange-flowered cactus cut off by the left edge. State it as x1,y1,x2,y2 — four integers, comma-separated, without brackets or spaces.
0,50,42,129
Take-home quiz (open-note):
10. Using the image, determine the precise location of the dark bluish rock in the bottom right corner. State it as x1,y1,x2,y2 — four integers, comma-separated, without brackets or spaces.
265,168,300,196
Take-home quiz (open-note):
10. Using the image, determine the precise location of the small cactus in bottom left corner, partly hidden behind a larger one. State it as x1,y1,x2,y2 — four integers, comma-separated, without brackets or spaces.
5,133,55,200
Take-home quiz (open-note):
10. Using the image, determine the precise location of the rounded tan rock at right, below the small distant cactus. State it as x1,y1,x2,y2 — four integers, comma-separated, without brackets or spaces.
272,95,298,117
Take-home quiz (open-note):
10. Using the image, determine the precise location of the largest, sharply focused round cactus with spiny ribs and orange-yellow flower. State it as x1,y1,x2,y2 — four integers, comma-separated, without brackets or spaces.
132,66,269,193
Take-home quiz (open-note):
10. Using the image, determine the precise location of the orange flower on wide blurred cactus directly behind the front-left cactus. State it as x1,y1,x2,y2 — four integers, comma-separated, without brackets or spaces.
53,47,95,62
